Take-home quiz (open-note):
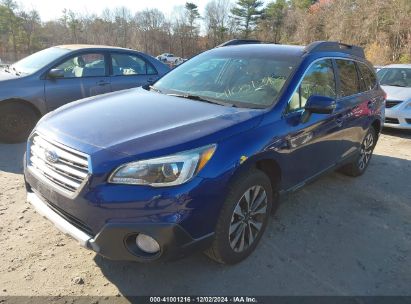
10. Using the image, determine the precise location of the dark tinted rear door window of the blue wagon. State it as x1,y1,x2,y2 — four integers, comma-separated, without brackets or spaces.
336,59,360,97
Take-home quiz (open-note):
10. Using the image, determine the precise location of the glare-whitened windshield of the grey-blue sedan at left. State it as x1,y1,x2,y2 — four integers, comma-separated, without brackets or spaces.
11,47,70,74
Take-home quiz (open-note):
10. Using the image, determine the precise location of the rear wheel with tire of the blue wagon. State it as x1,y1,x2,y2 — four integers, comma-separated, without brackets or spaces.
339,127,377,177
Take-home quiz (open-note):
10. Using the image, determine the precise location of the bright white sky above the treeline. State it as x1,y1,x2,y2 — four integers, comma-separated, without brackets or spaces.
17,0,212,21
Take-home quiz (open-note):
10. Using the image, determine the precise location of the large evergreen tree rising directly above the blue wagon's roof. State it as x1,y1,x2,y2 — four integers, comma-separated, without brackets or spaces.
231,0,263,38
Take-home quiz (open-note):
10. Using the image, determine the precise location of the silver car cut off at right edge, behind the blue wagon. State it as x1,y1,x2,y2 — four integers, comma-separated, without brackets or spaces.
377,64,411,130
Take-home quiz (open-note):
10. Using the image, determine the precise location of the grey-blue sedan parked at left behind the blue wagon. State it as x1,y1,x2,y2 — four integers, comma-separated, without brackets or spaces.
0,45,170,143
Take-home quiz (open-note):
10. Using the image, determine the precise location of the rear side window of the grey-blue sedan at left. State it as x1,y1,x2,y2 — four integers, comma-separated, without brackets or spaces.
111,54,157,76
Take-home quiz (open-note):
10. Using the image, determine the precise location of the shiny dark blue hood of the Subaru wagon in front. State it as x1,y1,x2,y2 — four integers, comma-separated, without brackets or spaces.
37,88,263,155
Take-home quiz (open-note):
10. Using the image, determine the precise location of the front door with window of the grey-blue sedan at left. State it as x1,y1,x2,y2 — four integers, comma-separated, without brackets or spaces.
45,52,111,111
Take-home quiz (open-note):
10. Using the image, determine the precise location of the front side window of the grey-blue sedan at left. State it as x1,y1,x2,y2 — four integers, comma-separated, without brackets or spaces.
55,53,106,78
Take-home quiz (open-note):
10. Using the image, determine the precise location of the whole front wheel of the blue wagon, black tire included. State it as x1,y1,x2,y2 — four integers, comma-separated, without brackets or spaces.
205,169,273,264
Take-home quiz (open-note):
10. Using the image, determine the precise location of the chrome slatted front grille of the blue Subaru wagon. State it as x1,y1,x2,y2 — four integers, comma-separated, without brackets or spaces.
30,134,89,193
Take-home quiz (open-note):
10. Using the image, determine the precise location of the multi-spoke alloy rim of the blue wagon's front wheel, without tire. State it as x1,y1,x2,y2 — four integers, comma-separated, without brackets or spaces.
229,186,267,252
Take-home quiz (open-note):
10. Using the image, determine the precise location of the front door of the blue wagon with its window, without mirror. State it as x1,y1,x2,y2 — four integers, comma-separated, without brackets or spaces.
282,59,345,189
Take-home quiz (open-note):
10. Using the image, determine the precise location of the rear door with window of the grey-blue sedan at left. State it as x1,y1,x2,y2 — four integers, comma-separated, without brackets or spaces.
110,52,159,91
